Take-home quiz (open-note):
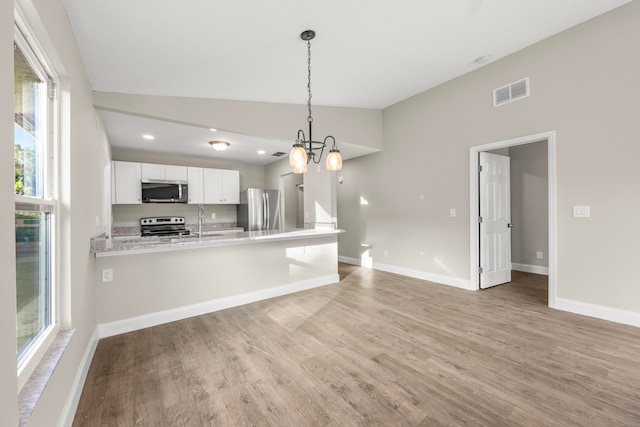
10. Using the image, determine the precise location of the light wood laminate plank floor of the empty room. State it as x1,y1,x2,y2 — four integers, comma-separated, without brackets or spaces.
74,264,640,427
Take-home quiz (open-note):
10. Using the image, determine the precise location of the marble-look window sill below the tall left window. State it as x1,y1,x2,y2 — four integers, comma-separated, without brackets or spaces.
18,329,74,426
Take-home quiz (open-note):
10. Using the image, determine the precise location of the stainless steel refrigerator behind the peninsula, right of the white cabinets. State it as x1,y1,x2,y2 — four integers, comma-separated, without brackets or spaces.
238,188,280,231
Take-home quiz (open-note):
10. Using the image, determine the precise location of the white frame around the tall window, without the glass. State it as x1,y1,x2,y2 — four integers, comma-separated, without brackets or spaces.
14,7,60,390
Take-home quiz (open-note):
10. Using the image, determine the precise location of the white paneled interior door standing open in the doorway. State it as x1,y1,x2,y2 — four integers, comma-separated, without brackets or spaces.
479,152,512,289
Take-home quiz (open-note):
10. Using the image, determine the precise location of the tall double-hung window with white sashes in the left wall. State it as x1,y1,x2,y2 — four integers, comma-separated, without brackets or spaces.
13,19,57,386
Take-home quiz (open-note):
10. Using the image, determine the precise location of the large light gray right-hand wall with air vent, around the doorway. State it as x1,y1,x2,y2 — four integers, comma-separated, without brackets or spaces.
338,1,640,312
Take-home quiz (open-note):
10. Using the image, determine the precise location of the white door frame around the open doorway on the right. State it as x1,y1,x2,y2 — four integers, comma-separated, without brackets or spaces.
469,131,558,308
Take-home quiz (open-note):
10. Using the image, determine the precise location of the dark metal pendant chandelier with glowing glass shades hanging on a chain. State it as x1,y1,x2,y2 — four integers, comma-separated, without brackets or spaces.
289,30,342,173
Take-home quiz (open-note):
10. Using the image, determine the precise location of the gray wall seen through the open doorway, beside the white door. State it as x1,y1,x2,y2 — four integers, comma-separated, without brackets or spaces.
509,141,549,269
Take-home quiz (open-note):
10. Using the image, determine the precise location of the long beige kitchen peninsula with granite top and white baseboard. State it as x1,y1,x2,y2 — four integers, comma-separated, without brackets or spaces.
91,228,342,337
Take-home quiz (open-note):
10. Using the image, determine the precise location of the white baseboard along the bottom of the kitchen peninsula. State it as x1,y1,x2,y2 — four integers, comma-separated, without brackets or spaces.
98,274,340,338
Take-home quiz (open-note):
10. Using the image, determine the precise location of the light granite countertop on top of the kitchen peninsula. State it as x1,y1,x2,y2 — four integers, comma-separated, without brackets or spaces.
91,228,344,257
